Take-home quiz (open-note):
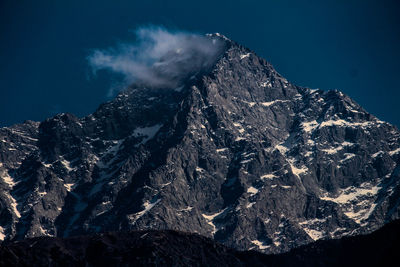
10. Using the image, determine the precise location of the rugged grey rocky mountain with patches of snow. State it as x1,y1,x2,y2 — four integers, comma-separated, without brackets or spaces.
0,34,400,253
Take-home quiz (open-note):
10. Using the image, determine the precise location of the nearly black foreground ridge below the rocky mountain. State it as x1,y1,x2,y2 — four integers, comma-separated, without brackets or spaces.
0,220,400,267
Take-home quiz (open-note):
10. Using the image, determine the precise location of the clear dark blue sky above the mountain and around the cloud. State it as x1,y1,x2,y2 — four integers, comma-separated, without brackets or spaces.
0,0,400,126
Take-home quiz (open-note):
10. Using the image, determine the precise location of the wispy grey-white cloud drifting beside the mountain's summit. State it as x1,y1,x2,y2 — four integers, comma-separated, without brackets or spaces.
87,27,224,91
